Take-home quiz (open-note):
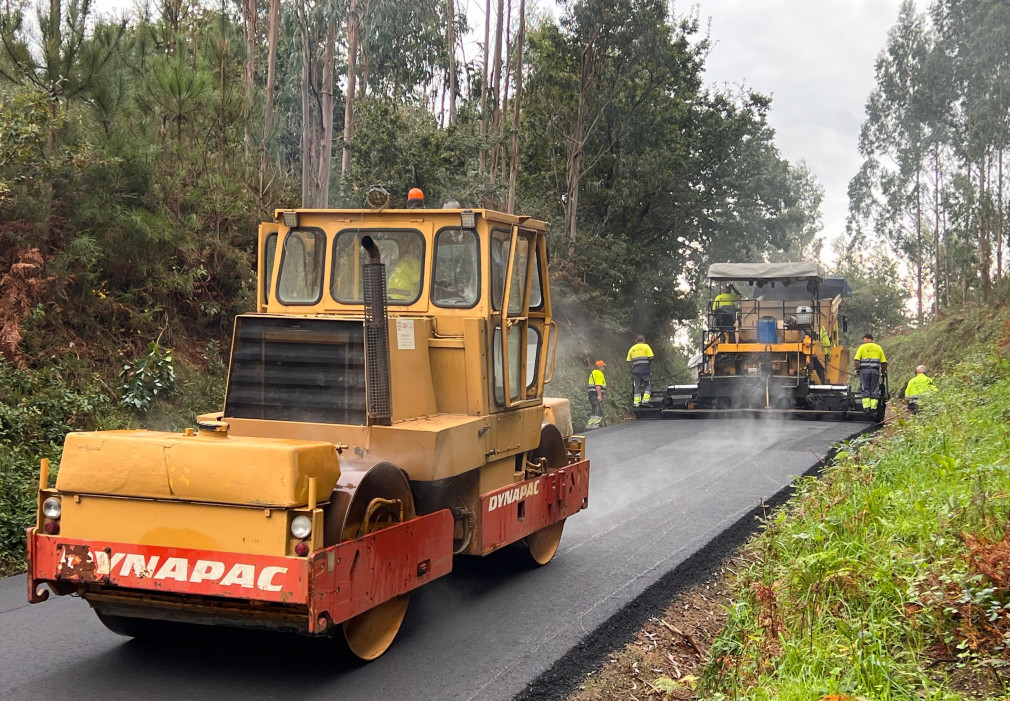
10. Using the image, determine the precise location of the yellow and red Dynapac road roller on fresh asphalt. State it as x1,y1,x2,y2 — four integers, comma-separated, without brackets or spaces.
28,199,589,660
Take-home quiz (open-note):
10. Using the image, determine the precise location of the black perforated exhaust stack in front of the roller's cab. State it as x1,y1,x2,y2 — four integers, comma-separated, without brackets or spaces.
362,236,393,426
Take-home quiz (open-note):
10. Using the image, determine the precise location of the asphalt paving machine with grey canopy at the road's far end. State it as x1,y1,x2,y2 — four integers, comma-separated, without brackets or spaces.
654,263,883,419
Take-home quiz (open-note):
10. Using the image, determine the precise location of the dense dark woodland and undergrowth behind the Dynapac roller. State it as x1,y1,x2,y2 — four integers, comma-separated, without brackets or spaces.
0,0,820,561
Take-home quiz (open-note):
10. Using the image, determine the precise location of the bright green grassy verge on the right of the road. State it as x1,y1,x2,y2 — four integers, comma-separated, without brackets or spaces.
704,353,1010,701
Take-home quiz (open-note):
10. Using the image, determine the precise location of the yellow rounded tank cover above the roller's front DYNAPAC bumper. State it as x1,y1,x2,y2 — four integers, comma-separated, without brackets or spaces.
57,430,340,507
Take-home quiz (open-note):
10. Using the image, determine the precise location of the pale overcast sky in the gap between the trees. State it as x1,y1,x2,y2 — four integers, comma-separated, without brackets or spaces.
694,0,927,254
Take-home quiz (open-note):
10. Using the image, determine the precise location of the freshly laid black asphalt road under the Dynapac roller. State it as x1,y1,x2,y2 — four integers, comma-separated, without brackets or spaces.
0,418,866,701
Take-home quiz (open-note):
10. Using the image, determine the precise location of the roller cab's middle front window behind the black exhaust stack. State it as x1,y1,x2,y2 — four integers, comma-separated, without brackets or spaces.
329,229,424,304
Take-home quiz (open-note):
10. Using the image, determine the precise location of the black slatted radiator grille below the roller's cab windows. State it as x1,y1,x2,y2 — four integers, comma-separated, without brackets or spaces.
224,316,368,425
